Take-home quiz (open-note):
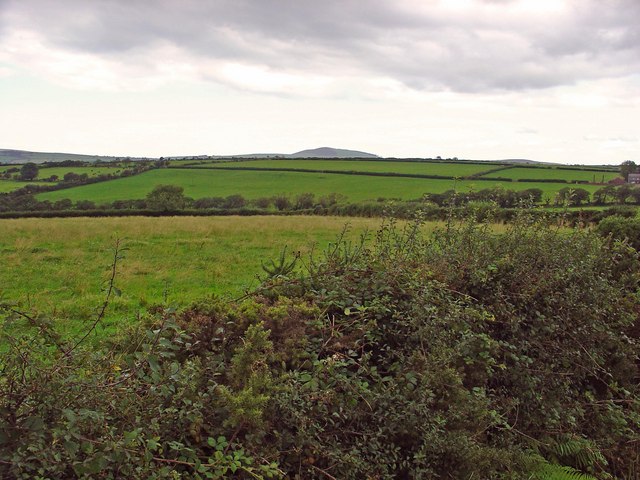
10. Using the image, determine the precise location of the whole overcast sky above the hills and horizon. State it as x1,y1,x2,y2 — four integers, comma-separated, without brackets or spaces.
0,0,640,164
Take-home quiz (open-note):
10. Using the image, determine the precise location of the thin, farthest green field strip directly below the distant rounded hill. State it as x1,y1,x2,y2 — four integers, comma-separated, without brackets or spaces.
194,159,499,177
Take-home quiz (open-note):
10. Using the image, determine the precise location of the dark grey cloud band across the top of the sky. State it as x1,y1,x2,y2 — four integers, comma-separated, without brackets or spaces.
0,0,640,92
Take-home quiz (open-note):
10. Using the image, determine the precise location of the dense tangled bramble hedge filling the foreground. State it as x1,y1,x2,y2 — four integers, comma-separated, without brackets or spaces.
0,214,640,480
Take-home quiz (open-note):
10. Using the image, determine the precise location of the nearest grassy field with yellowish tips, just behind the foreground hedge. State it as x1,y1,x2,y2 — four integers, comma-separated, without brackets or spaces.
0,217,390,332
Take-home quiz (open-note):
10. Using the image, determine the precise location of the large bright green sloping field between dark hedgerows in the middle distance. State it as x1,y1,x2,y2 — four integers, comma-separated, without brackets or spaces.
38,169,600,203
